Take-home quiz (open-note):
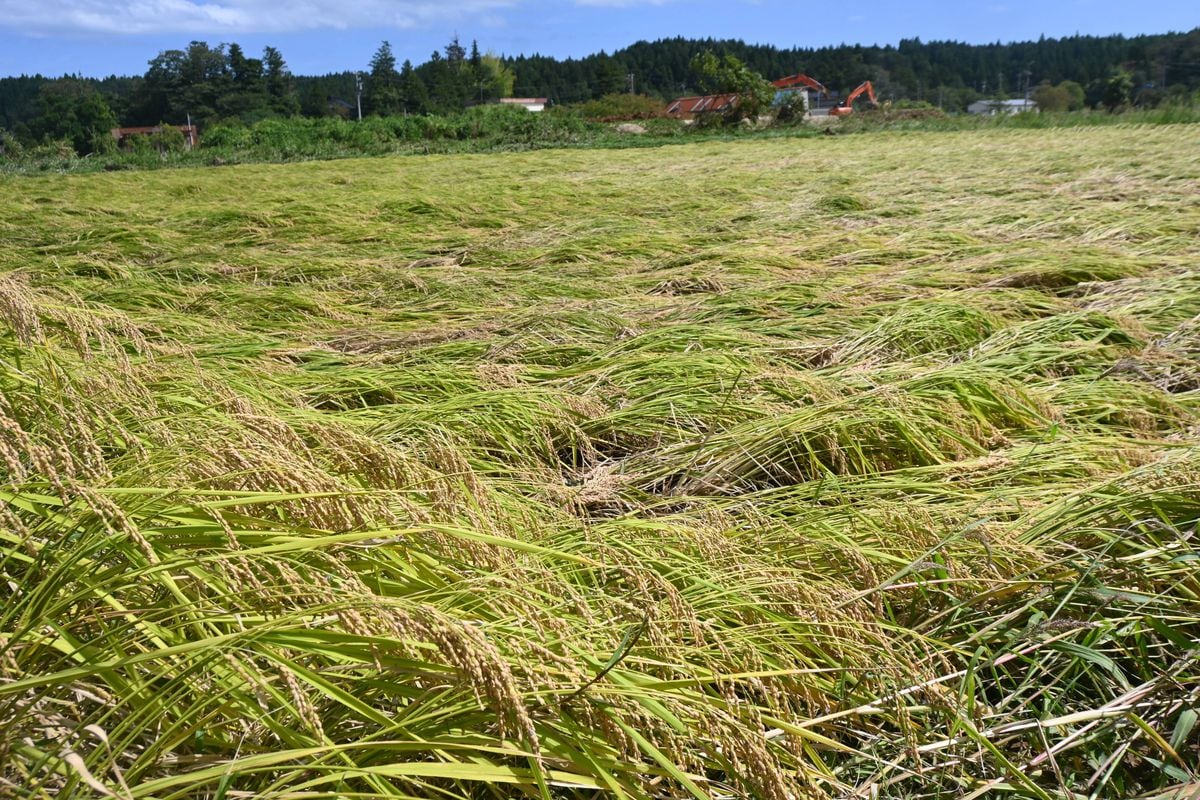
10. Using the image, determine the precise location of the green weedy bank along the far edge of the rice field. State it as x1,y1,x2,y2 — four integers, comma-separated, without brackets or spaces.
7,106,1200,174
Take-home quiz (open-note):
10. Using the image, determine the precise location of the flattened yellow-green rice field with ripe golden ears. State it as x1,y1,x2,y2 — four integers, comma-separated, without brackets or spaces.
0,126,1200,800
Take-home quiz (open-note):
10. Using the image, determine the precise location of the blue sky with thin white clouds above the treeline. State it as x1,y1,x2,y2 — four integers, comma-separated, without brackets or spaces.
0,0,1200,76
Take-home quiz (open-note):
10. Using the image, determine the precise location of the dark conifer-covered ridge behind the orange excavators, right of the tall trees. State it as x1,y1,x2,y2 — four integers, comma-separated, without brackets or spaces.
523,28,1200,104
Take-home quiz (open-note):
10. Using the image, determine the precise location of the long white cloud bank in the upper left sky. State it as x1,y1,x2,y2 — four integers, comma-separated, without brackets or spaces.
0,0,516,35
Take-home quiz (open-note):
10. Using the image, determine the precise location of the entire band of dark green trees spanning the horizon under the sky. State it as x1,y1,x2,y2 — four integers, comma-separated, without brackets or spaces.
0,28,1200,152
